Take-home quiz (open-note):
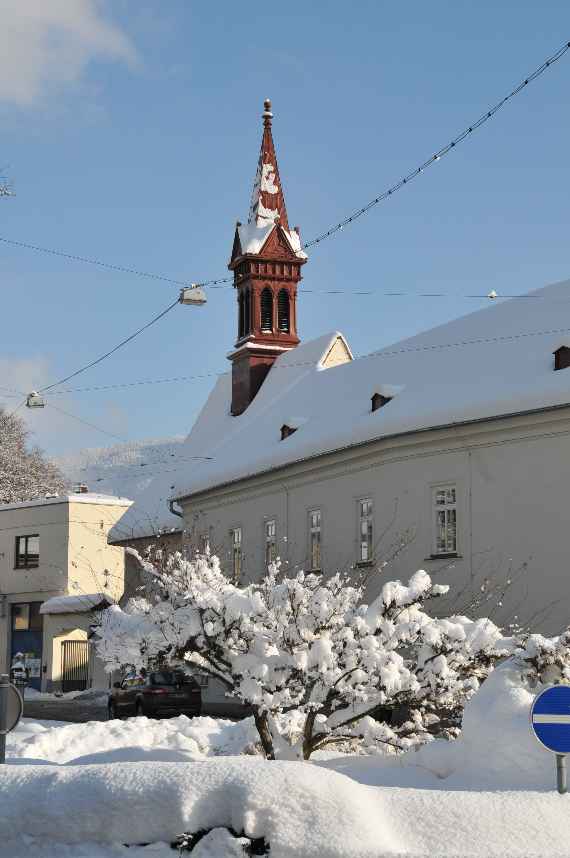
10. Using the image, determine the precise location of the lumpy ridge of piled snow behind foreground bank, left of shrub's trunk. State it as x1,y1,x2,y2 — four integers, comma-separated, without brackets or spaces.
8,715,257,765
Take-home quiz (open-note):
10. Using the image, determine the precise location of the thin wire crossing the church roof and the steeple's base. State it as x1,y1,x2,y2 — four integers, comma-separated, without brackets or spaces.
41,320,570,396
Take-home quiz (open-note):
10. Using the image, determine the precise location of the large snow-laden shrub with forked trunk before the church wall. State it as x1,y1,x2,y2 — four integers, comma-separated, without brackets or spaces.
97,553,512,759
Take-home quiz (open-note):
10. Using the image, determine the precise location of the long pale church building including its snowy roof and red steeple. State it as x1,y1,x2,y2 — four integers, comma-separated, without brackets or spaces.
113,103,570,633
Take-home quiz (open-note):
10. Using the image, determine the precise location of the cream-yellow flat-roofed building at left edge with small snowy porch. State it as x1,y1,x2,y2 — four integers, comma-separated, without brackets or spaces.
0,492,131,691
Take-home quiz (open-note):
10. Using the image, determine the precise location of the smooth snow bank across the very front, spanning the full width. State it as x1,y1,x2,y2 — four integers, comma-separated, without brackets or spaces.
0,757,570,858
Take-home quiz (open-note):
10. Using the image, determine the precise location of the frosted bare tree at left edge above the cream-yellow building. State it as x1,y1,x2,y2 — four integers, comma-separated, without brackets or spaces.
0,406,66,503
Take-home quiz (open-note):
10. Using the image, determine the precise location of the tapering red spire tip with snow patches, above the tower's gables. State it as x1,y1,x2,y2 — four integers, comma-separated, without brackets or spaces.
248,98,289,230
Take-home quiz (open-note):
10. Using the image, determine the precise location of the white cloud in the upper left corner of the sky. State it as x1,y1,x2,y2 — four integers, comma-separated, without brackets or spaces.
0,0,136,107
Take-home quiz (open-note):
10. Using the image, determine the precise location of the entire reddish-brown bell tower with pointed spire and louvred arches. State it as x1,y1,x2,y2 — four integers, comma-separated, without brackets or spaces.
228,99,307,416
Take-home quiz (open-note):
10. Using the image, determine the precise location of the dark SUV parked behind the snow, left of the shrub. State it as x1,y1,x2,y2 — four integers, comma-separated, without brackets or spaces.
109,670,202,718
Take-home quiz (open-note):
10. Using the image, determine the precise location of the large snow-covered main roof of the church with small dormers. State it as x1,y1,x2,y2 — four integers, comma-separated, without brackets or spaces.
153,281,570,498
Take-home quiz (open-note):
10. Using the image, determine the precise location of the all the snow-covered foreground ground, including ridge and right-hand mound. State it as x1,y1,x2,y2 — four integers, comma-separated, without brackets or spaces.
0,664,570,858
